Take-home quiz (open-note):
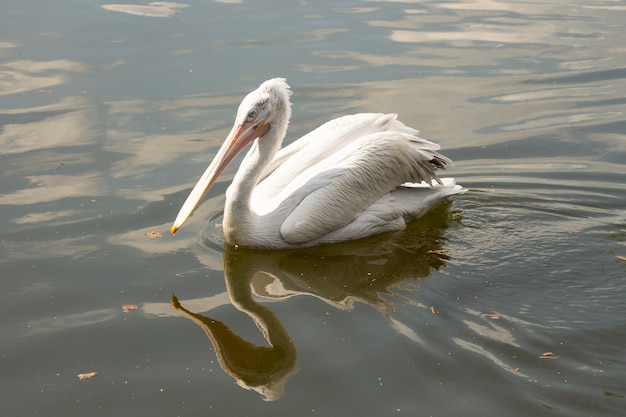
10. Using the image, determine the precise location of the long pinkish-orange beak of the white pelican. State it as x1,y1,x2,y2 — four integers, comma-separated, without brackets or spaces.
170,123,270,234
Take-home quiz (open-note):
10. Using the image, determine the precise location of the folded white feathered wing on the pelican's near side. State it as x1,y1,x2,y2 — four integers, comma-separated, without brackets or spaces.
276,127,451,244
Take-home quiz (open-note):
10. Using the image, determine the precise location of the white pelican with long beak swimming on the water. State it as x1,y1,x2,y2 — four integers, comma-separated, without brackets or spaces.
171,78,465,249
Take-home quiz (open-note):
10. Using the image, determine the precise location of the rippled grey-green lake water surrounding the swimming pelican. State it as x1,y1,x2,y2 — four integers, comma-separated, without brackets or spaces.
0,0,626,417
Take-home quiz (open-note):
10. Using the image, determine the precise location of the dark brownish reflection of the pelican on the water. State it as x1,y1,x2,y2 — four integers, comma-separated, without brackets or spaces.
172,204,454,401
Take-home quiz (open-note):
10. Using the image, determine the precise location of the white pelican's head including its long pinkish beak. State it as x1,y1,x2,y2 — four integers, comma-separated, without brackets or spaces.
171,78,291,234
